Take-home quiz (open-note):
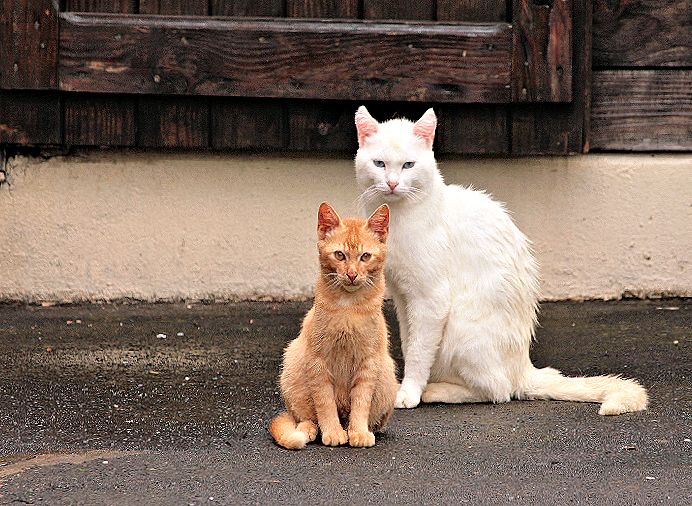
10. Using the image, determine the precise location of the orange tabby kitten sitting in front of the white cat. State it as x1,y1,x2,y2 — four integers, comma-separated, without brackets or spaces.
269,202,398,449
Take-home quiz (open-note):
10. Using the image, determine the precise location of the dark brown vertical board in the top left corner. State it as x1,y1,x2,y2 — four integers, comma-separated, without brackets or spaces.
0,0,58,89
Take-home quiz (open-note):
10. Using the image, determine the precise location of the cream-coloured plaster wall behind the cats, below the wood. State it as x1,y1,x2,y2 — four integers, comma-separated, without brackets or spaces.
0,152,692,301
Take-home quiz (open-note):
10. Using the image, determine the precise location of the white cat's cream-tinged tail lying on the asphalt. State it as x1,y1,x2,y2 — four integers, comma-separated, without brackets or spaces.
521,367,649,415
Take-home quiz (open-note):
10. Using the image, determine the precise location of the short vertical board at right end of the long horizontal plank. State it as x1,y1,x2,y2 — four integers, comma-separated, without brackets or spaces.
512,0,572,102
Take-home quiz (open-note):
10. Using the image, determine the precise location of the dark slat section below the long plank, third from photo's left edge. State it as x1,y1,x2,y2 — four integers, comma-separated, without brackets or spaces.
137,97,209,148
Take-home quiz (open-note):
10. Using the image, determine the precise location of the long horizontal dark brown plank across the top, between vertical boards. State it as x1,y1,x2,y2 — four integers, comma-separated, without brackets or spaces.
59,13,511,103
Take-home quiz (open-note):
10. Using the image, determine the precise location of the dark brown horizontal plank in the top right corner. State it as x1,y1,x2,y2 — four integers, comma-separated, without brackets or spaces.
593,0,692,68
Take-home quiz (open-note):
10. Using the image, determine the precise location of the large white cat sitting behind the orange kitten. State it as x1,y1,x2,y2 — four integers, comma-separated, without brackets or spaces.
355,106,648,415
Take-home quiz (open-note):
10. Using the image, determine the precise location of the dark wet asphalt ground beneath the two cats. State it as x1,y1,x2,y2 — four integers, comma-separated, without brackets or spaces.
0,299,692,505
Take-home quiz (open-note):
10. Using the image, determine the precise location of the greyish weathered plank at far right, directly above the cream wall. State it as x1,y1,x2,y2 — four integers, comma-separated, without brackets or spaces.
591,69,692,151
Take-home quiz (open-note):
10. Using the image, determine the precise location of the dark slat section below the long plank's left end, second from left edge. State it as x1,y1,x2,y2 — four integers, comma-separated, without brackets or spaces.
63,94,136,146
